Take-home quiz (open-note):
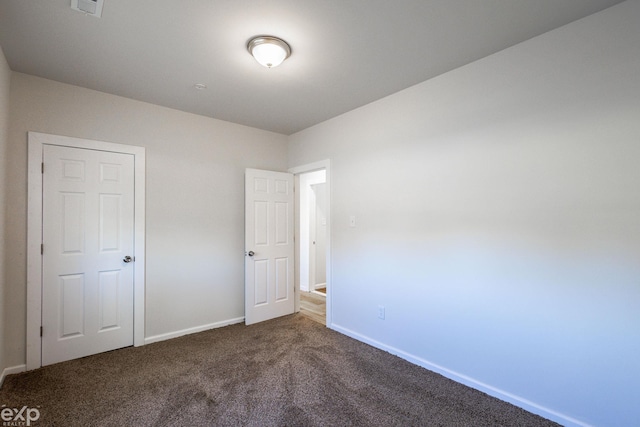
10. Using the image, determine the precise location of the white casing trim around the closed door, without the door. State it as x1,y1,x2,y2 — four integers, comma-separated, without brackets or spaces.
26,132,146,370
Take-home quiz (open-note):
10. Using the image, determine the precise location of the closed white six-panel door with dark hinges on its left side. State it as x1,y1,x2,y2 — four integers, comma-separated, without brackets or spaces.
42,145,134,365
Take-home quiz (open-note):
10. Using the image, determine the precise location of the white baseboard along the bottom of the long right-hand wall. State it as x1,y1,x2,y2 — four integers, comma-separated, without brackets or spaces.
330,323,591,427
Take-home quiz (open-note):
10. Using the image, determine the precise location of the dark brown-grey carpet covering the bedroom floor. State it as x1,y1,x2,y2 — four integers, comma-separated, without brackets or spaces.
0,315,557,426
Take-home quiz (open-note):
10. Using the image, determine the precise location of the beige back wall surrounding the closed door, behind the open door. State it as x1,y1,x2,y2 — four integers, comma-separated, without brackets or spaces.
5,73,286,366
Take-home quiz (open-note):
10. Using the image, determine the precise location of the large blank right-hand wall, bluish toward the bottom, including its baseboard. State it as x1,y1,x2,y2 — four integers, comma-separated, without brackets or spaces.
289,1,640,426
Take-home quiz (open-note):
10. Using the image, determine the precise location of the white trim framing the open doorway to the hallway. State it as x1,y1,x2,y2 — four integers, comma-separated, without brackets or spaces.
288,159,334,329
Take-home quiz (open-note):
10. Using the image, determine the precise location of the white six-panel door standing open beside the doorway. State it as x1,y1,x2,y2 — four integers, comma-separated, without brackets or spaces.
245,169,295,325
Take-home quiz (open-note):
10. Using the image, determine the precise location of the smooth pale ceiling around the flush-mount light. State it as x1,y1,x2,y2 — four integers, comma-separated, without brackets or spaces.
0,0,621,135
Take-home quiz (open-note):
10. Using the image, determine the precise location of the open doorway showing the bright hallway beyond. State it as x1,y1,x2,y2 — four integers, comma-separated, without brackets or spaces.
292,162,331,325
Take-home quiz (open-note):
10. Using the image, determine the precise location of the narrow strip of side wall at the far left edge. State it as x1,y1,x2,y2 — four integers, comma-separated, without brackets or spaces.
0,47,11,378
